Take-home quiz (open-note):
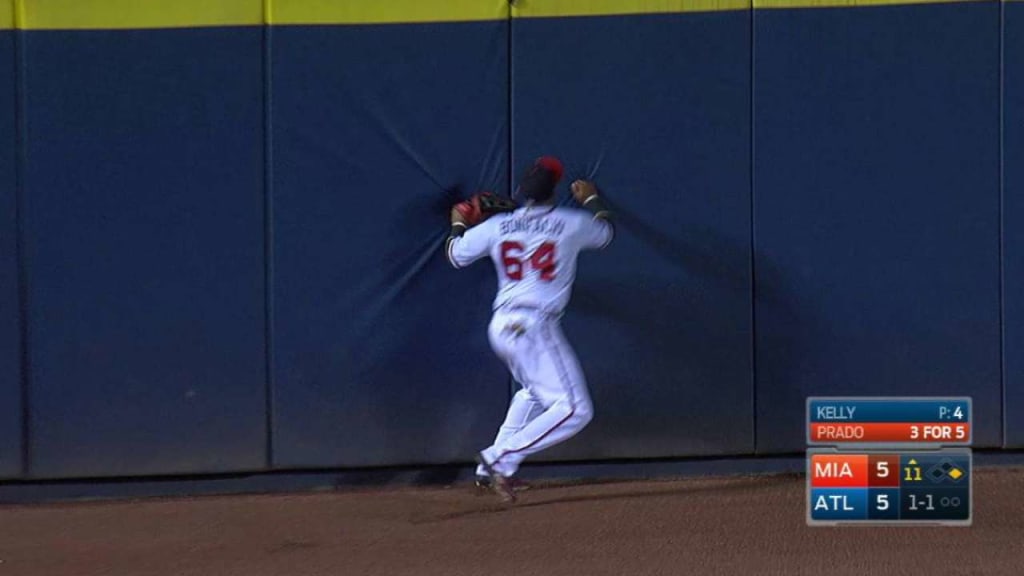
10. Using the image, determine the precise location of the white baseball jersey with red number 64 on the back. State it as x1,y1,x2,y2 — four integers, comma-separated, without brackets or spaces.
447,206,612,314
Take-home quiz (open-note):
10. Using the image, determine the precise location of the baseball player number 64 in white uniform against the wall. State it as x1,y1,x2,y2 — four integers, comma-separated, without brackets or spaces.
445,157,613,502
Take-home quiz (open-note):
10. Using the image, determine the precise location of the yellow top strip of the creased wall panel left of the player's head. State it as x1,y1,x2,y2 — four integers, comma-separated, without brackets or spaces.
267,0,509,25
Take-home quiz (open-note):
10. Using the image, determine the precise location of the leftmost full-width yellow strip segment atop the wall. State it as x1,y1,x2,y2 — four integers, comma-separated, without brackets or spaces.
15,0,263,30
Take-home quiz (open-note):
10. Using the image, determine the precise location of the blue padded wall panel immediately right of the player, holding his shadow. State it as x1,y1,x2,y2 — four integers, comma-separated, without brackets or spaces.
512,11,754,460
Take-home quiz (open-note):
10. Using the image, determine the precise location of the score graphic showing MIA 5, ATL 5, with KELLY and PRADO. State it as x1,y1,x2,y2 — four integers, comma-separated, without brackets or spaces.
807,398,974,526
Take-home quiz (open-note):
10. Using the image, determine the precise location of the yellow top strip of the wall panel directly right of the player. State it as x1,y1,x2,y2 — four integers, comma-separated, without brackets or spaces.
512,0,751,18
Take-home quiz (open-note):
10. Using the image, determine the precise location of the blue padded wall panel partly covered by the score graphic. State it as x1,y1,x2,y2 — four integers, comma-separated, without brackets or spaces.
754,2,1001,453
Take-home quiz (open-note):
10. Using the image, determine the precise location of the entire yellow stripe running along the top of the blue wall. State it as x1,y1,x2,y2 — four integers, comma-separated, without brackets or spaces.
0,0,1007,30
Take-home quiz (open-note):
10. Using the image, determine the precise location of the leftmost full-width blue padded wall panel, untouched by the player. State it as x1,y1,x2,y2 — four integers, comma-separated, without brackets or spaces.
24,27,266,478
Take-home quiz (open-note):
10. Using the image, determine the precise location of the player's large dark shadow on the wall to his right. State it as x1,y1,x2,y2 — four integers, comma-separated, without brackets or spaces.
553,196,820,459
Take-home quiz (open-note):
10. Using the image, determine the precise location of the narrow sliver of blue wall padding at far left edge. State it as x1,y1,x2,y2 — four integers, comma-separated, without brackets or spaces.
0,30,22,478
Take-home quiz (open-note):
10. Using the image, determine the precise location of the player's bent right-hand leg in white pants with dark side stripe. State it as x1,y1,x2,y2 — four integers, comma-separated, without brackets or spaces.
482,321,594,476
